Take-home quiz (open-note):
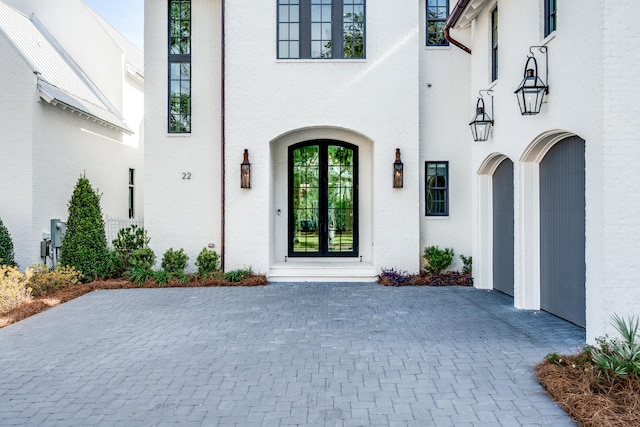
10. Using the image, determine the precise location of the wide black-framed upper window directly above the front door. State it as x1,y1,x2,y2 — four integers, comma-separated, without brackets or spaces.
278,0,366,59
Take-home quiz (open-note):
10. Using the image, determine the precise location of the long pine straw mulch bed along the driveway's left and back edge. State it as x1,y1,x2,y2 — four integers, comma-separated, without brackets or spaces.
0,275,268,328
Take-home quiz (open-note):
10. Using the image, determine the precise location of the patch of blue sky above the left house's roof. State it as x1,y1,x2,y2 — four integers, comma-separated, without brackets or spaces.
84,0,144,49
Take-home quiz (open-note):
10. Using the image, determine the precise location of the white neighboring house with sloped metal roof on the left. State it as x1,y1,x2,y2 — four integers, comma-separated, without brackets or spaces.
0,0,144,269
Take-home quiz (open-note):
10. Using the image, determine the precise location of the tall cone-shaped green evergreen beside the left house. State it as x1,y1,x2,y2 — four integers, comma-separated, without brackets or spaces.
60,176,112,280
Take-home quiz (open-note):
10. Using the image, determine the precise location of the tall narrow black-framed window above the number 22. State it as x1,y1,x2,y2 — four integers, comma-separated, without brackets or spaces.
168,0,191,133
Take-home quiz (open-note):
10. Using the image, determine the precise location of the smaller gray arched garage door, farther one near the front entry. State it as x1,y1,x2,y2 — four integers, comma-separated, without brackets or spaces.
493,159,513,296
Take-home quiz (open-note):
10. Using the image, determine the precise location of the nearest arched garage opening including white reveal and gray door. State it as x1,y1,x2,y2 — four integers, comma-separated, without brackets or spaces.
521,131,586,326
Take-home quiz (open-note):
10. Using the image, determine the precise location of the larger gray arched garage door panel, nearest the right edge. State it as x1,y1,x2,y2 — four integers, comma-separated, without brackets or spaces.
540,137,585,326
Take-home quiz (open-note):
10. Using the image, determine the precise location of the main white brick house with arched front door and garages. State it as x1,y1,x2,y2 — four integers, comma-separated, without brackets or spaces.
145,0,640,341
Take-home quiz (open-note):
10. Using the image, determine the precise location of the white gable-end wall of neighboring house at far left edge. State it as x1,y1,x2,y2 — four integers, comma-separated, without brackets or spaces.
0,34,36,268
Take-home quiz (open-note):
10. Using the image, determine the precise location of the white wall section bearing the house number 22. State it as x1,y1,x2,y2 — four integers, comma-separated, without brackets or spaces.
145,0,222,269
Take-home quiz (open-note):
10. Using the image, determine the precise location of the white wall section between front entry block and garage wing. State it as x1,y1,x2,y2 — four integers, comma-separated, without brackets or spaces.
419,1,475,270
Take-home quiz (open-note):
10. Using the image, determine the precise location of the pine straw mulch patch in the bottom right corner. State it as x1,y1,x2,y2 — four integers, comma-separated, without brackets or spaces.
535,353,640,427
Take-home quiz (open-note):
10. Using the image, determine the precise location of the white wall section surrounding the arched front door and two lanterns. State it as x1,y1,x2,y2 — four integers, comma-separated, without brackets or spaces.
225,0,422,272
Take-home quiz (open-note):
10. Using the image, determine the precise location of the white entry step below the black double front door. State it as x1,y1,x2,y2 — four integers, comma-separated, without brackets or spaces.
267,260,377,282
